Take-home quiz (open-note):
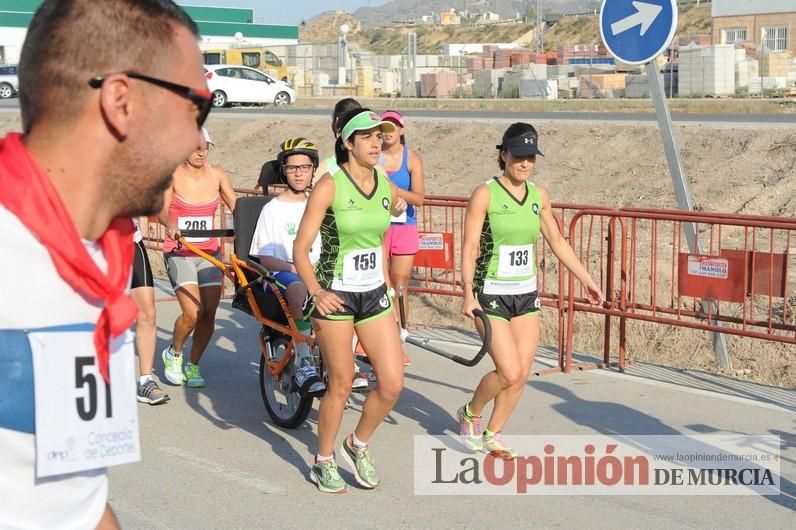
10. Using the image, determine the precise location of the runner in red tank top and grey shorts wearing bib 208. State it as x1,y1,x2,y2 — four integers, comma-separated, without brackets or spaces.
159,129,236,388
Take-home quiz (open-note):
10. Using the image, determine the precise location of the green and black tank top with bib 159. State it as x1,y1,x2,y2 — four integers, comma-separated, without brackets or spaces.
315,167,392,292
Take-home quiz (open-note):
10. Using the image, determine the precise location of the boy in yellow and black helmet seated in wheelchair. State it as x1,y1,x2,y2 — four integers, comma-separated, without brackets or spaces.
249,138,326,396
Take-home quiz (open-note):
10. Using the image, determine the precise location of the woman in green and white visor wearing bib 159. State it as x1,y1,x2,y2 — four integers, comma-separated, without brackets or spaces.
293,109,406,493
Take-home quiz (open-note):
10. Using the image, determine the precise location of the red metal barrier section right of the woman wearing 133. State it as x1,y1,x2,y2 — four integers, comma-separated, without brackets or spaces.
564,208,796,371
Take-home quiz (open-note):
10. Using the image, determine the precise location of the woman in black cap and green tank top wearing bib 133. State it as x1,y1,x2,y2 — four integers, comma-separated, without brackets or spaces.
456,123,603,459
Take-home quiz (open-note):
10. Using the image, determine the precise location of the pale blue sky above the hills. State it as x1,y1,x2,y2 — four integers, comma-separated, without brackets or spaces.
182,0,380,25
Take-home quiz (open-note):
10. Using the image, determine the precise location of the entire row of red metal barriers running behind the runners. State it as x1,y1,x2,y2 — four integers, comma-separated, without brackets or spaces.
141,189,796,372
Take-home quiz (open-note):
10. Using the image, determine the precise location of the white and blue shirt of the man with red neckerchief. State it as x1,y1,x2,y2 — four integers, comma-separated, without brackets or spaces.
0,206,124,528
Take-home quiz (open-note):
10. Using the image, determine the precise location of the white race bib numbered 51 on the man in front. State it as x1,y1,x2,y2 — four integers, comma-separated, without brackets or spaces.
28,330,141,478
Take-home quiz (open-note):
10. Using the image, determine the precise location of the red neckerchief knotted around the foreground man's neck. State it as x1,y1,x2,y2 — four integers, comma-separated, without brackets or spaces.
0,133,138,383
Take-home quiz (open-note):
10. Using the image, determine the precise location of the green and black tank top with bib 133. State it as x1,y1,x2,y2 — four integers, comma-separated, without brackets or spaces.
473,178,542,295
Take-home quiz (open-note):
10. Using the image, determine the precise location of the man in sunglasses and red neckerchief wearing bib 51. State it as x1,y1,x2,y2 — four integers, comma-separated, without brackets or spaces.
0,0,210,528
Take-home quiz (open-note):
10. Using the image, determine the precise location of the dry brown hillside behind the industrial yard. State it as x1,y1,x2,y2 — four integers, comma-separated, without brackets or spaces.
300,4,711,55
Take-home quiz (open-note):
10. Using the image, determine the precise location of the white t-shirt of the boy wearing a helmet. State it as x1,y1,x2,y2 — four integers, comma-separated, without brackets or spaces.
249,197,321,264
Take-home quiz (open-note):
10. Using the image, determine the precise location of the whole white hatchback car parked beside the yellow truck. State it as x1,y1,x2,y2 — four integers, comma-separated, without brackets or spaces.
205,64,296,107
